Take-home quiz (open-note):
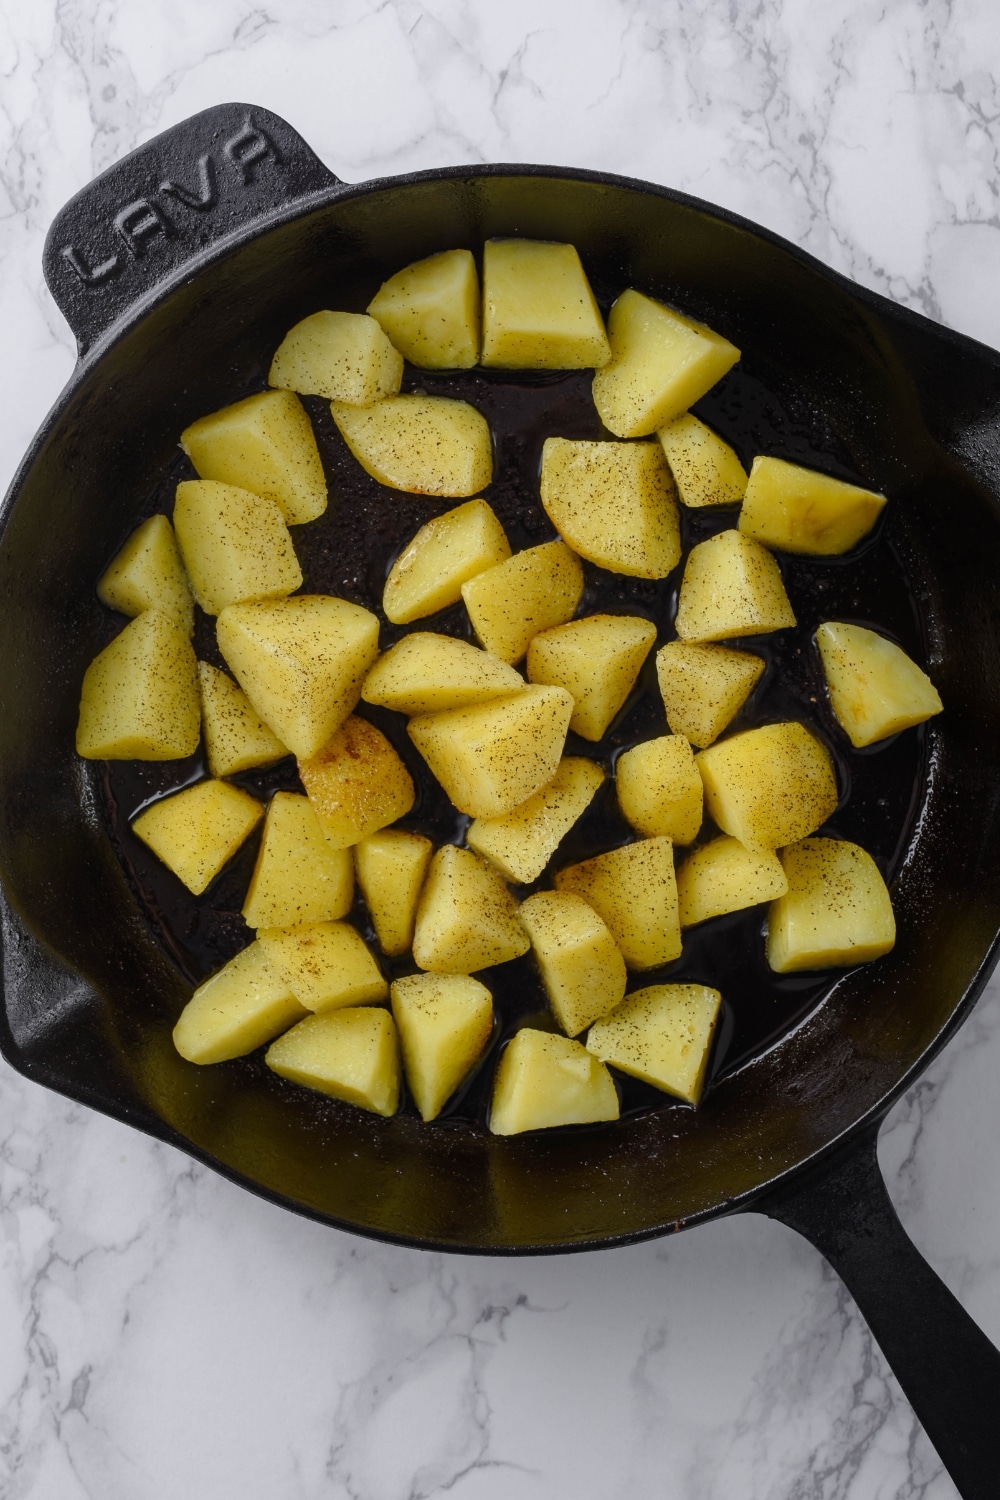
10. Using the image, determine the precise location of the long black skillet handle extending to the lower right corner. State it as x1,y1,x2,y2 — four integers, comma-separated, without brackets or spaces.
751,1125,1000,1500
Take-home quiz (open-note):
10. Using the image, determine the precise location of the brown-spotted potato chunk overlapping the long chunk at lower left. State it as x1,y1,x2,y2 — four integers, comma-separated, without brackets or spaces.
256,923,388,1011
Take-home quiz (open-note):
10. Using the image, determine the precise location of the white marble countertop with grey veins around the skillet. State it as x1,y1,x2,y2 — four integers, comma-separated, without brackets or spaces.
0,0,1000,1500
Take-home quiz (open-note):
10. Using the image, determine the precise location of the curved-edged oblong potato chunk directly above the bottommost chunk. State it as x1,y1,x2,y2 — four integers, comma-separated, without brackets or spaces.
520,891,625,1037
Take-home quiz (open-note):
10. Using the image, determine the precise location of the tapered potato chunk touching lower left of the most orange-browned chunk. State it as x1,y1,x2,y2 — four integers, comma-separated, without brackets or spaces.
243,792,354,929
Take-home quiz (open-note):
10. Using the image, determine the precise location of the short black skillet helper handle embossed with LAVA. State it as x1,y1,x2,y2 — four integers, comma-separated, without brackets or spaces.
42,104,339,356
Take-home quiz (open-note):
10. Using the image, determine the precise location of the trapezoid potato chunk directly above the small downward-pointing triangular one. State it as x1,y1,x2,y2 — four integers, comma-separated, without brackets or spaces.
675,531,796,641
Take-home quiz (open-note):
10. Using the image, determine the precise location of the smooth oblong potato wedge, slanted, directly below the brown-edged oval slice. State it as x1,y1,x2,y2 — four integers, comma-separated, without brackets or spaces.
382,500,510,626
